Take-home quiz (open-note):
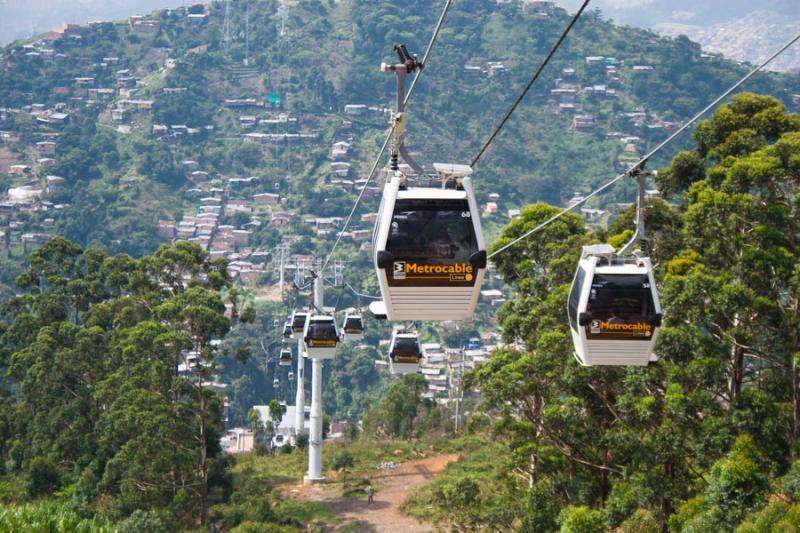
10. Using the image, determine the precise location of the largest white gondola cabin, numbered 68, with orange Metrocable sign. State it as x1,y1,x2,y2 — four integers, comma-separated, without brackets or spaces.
373,163,486,320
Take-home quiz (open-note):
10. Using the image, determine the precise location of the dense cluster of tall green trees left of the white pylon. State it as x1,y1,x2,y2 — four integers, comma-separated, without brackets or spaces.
0,238,253,527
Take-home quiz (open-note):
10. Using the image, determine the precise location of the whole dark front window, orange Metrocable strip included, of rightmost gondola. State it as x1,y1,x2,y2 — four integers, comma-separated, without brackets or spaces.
588,274,655,341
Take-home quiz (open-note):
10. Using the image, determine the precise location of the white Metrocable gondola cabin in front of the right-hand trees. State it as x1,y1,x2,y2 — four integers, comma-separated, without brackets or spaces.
567,244,661,366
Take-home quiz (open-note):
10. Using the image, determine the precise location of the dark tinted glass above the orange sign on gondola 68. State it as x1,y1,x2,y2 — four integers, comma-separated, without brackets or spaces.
386,200,478,265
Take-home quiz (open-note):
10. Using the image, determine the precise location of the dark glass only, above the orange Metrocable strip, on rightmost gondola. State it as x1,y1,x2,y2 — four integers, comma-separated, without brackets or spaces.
587,274,655,322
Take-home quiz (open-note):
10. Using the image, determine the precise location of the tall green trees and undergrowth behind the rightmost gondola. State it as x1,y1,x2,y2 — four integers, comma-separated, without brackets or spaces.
406,94,800,532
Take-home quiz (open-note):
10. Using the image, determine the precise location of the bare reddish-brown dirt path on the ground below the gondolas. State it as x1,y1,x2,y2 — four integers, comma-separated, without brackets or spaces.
286,454,459,533
